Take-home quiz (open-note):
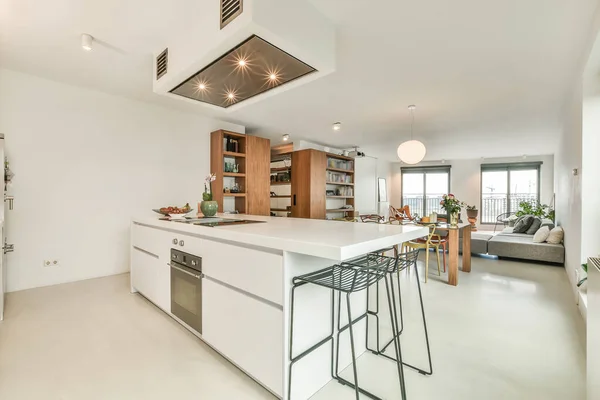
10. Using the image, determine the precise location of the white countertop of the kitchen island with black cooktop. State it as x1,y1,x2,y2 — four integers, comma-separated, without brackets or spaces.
132,214,429,261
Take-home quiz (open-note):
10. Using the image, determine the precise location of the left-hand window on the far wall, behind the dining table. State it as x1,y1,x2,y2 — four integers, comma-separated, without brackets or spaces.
402,167,450,216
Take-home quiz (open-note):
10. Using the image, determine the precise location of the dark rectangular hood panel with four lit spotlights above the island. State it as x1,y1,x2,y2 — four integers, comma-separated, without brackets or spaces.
171,35,316,108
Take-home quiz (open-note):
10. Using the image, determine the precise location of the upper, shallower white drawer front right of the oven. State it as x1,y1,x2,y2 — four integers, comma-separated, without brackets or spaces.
202,240,283,305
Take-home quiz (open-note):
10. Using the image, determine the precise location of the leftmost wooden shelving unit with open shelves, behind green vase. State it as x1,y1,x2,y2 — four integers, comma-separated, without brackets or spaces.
210,130,271,215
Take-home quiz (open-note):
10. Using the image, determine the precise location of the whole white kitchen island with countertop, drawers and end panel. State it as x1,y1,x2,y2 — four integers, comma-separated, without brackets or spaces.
131,215,428,400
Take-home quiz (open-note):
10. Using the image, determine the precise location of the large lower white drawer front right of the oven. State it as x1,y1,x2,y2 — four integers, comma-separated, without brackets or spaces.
202,278,283,396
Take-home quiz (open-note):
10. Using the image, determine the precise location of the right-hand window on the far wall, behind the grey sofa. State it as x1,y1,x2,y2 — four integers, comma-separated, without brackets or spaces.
481,163,542,224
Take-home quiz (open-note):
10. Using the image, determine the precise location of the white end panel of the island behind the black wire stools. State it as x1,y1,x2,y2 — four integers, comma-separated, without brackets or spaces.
283,252,367,400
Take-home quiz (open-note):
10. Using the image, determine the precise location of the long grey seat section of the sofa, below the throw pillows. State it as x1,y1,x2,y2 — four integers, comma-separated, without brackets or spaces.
488,235,565,264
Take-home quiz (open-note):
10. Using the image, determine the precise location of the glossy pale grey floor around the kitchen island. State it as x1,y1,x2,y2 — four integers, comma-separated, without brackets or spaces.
0,258,585,400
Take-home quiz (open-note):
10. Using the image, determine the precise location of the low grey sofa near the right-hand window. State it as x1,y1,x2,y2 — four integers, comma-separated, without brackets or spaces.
460,219,565,264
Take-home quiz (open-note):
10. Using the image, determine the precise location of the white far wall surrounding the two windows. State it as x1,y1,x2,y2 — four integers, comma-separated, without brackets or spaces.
391,155,554,222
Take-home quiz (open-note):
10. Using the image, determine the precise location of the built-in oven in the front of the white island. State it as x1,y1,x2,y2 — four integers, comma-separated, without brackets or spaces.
171,249,204,334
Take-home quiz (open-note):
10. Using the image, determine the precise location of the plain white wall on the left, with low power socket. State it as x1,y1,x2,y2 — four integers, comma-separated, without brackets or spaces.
0,70,244,291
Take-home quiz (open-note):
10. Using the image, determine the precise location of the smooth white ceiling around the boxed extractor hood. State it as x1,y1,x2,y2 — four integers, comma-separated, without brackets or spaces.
0,0,598,160
